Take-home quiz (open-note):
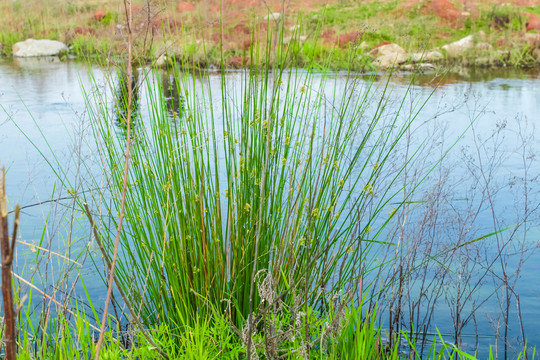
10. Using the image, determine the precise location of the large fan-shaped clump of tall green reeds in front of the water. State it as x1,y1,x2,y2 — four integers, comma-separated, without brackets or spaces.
81,24,434,349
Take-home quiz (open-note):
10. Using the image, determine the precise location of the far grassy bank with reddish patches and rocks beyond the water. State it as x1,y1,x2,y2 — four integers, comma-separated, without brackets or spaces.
0,0,540,71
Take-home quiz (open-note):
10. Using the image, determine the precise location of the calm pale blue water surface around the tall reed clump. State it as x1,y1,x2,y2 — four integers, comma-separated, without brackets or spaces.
0,59,540,358
